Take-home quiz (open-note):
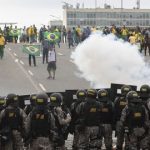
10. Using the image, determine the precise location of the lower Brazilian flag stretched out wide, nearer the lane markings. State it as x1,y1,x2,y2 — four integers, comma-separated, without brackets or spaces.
22,44,41,56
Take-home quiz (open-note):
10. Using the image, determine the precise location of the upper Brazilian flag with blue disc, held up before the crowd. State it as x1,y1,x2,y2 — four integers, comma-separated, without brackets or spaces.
44,31,59,43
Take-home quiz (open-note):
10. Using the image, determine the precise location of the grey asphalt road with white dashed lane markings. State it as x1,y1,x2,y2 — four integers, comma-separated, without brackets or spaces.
0,43,90,96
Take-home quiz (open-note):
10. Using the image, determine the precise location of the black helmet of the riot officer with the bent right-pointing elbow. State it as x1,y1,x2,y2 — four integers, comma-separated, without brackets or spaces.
50,93,63,107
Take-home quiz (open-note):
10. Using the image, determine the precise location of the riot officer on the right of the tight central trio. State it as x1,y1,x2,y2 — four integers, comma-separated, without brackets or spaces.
98,89,114,150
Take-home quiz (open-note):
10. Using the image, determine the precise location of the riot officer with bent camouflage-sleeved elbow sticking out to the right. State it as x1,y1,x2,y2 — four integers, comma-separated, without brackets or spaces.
50,93,71,150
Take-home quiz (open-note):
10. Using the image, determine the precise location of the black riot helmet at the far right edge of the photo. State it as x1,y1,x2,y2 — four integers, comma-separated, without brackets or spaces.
140,84,150,98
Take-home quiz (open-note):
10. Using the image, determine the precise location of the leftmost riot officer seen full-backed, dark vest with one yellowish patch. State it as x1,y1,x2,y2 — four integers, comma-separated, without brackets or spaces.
0,94,26,150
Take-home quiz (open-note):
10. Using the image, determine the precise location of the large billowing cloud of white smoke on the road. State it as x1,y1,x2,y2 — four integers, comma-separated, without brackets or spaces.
71,33,150,88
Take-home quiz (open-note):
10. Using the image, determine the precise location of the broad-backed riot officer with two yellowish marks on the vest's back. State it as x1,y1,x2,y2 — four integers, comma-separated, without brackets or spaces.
26,93,56,150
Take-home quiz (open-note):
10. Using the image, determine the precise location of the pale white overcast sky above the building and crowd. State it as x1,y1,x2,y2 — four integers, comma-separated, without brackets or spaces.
0,0,150,26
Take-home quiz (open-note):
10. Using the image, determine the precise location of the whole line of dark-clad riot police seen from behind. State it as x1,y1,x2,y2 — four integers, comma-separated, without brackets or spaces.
0,85,150,150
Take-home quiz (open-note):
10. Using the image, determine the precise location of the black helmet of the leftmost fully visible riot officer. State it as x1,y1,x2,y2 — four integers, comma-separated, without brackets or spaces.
6,93,19,106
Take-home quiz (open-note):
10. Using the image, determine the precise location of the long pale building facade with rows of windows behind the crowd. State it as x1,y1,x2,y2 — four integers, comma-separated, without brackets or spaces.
63,8,150,28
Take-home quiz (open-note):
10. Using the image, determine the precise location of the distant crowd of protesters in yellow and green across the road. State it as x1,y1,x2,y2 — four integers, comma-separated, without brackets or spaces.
0,25,150,55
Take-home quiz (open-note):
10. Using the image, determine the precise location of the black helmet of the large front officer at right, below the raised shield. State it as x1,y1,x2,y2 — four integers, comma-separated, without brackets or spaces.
126,91,141,103
